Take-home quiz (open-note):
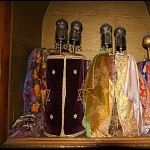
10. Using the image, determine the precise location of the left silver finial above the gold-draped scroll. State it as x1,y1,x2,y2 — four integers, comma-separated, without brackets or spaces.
100,23,112,48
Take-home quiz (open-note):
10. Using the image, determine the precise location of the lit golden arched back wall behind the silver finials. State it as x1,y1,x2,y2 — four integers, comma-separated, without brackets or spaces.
42,1,150,61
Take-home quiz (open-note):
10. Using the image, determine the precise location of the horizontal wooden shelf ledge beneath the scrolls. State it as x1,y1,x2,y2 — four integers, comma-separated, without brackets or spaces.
0,137,150,148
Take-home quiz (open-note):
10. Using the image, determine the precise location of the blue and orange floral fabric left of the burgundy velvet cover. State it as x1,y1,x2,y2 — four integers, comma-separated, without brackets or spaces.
23,48,47,112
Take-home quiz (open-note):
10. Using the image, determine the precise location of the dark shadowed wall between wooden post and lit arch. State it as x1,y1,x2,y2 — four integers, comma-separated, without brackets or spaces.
10,1,49,126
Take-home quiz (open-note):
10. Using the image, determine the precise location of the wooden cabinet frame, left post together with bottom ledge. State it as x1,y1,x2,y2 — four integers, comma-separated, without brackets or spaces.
0,1,150,148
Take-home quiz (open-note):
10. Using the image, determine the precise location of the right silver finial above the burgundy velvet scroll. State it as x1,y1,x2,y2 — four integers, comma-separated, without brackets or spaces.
69,20,83,53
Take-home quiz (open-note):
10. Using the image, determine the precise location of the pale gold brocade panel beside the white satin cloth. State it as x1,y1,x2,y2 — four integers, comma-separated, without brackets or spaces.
115,55,138,137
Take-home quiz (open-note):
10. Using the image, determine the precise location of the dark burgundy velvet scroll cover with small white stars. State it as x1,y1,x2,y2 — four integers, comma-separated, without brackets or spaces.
44,55,88,137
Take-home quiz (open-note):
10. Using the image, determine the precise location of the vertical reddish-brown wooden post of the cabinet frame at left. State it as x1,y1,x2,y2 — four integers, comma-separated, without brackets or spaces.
0,1,12,144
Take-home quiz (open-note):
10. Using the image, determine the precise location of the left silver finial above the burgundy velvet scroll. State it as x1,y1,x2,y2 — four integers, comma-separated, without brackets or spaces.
55,18,68,53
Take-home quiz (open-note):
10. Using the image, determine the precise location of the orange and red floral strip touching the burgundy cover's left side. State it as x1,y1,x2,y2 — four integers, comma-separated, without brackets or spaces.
31,49,47,112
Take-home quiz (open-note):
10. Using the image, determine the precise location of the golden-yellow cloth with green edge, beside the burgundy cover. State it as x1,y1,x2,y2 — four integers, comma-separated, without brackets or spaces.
83,51,110,137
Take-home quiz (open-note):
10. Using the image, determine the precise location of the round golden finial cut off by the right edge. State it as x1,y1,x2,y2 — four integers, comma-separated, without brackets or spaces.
142,34,150,59
